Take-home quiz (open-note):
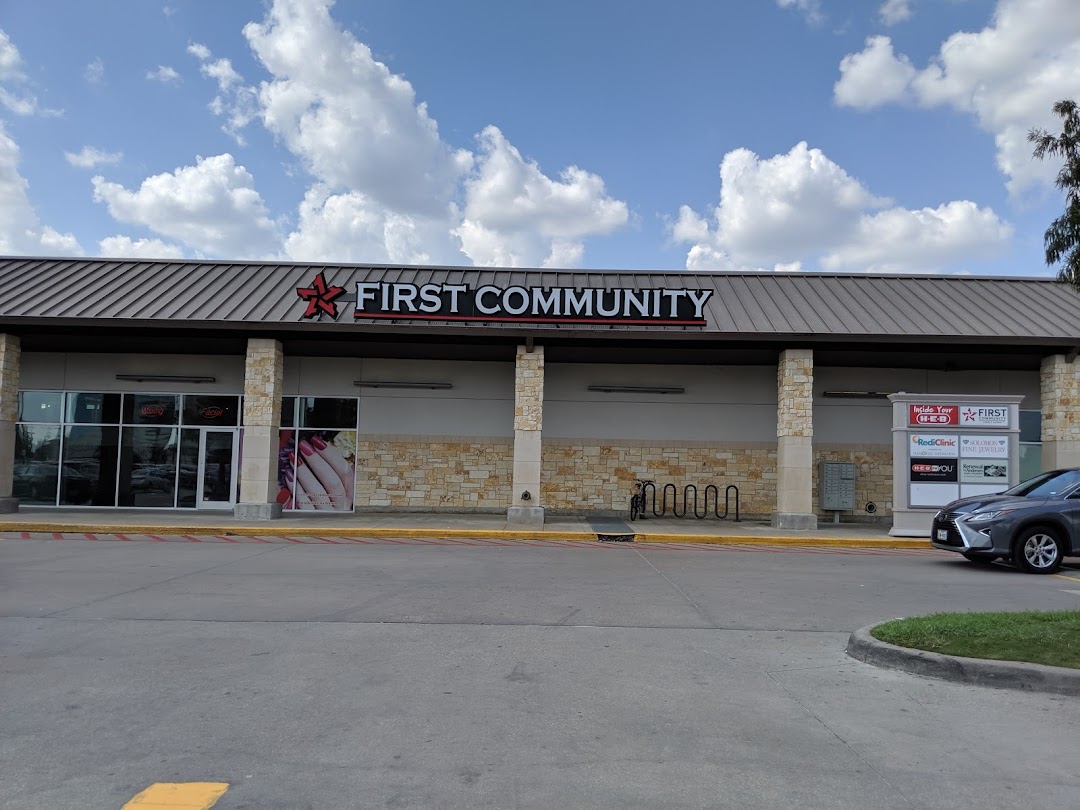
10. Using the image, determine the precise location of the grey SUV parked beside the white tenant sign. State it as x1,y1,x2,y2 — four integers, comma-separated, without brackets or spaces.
930,470,1080,573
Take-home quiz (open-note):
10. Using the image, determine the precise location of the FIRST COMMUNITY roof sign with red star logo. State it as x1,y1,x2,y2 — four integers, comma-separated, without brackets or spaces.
296,272,713,326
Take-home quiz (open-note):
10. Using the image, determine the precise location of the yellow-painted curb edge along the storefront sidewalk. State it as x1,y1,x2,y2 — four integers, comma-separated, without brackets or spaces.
0,521,930,549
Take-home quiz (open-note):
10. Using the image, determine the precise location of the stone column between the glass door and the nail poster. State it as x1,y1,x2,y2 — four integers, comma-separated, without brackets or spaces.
234,338,284,521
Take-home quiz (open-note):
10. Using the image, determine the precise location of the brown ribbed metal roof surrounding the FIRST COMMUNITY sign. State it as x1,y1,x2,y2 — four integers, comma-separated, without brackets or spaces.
0,257,1080,347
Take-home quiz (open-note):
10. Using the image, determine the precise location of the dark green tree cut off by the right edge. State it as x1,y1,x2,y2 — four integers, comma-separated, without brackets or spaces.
1027,99,1080,291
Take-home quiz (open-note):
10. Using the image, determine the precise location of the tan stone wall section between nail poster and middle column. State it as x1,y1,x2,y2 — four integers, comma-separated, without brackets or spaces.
355,433,514,511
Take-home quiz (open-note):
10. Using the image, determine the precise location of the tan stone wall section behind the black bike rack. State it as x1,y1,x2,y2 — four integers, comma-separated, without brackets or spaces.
540,438,777,515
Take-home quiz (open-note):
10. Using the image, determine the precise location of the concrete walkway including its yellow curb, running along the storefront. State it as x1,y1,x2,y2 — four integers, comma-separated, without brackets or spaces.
0,508,930,549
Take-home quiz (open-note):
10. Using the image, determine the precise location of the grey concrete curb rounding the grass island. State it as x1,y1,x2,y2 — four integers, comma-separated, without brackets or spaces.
847,624,1080,697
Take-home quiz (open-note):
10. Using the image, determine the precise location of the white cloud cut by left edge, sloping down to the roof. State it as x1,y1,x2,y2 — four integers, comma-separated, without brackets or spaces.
0,124,82,256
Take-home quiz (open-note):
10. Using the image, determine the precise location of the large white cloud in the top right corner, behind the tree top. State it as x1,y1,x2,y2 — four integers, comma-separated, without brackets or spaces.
834,0,1080,193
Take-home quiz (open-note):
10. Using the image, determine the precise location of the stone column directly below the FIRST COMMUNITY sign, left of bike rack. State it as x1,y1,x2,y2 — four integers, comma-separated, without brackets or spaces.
507,346,543,527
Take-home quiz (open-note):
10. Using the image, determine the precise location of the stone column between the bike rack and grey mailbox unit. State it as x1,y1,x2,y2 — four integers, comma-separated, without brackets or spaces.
772,349,818,529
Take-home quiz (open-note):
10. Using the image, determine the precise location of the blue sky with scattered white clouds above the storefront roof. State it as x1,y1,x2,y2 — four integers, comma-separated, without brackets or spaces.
0,0,1080,275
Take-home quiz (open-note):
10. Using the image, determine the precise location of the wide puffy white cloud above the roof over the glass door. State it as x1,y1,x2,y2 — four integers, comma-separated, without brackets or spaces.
93,153,279,258
